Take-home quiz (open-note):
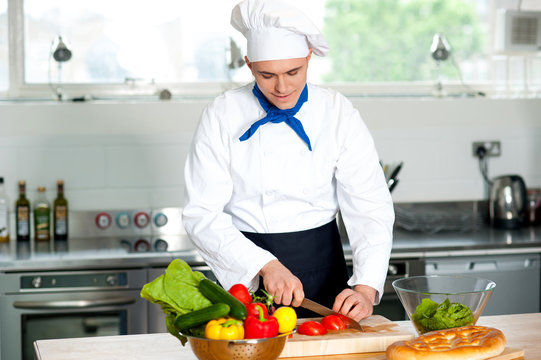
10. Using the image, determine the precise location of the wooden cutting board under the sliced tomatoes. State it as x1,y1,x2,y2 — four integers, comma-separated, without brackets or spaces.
280,315,415,358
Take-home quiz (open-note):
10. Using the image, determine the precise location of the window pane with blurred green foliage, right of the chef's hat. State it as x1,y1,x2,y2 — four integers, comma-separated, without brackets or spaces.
323,0,486,82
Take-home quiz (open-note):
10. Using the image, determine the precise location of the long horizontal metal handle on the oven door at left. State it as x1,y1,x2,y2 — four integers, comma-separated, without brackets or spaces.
13,296,136,310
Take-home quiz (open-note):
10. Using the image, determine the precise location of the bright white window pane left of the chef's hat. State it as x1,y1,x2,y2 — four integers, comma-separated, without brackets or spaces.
24,0,252,84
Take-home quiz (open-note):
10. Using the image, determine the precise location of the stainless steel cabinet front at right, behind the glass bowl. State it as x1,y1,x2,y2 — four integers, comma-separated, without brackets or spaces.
425,253,541,315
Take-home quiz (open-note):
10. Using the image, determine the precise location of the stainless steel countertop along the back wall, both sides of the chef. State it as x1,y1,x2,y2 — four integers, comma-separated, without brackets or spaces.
0,226,541,272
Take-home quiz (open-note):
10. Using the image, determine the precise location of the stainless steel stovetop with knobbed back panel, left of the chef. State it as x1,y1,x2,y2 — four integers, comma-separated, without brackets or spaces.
0,208,203,271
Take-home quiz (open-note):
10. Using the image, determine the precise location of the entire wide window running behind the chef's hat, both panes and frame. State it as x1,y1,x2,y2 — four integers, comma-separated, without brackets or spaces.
0,0,541,96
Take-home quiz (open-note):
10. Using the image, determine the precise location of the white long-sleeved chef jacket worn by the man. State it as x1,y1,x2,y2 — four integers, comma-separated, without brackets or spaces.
183,83,394,304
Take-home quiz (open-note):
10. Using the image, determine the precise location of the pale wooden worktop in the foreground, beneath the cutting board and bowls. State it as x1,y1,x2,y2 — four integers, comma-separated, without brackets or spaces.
34,313,541,360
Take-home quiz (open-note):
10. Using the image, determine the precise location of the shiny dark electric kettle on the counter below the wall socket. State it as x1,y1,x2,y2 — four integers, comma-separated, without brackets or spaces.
489,175,527,229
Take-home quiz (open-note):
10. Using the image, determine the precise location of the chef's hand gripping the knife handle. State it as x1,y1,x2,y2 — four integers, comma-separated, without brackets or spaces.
259,260,304,307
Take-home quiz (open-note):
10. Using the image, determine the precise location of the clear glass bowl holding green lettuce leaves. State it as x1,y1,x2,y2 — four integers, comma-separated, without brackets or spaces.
393,275,496,334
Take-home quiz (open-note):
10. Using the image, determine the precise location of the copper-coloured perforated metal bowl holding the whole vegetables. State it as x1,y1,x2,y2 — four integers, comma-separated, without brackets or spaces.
182,332,291,360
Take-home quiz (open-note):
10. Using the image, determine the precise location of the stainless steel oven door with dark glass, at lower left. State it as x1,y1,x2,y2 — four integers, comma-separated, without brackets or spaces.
0,290,147,360
